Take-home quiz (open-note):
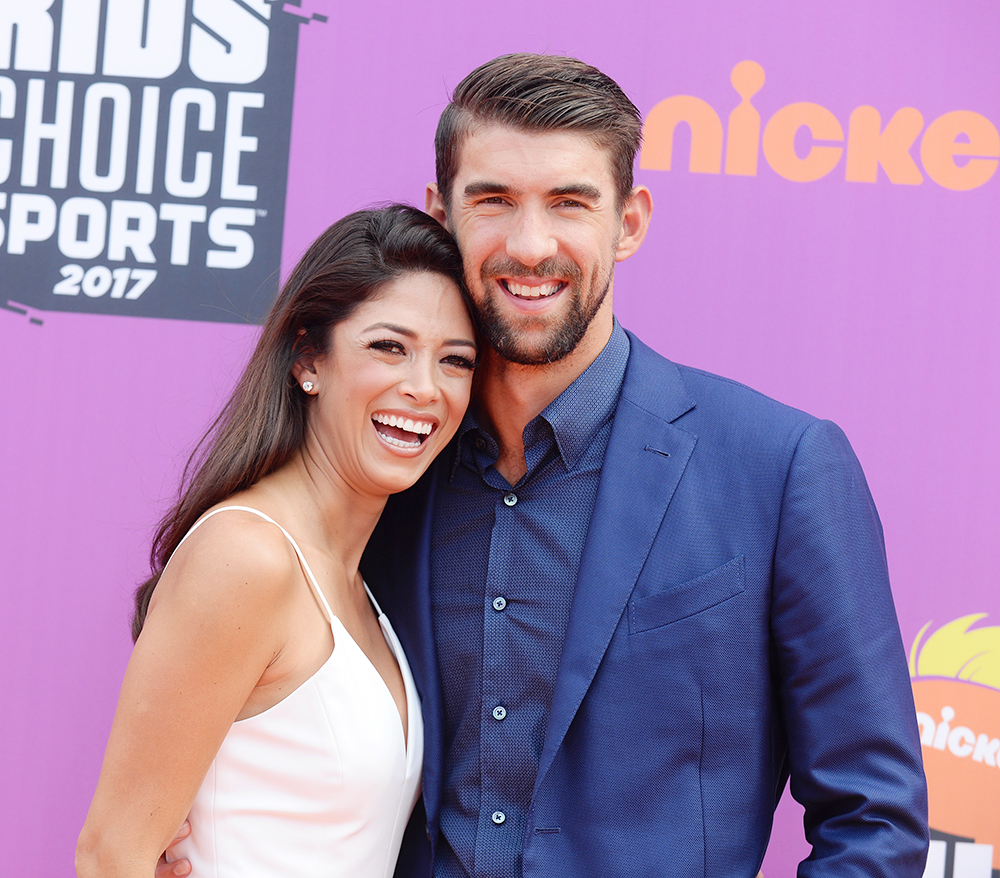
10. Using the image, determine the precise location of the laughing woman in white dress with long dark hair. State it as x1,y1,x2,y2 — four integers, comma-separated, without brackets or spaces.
77,205,476,878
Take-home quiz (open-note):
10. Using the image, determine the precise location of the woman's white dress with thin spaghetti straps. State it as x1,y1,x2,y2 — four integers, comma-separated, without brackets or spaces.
171,506,424,878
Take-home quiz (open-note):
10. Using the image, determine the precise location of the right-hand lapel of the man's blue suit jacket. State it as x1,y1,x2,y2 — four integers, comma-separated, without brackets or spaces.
535,335,695,793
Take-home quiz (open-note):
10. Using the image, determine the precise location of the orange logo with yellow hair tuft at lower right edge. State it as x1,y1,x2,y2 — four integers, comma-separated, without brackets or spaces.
910,613,1000,878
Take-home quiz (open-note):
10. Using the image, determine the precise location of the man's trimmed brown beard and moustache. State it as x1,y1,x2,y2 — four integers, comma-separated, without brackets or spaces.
474,259,611,366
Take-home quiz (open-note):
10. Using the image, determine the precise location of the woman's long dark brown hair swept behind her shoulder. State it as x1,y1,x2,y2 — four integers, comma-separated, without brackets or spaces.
132,210,465,640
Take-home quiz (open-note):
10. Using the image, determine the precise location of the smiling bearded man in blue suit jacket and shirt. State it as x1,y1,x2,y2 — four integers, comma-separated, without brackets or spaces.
162,55,927,878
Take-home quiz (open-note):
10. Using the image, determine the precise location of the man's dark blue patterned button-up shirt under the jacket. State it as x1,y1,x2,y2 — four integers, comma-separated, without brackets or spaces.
431,321,629,878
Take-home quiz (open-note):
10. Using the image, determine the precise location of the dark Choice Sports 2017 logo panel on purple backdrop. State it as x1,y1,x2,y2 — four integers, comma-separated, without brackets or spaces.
0,0,310,322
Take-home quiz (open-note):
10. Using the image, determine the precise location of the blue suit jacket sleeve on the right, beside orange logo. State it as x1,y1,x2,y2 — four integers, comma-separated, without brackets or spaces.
771,421,928,878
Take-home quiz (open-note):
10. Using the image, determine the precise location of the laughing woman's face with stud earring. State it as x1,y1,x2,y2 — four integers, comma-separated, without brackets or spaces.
296,272,476,495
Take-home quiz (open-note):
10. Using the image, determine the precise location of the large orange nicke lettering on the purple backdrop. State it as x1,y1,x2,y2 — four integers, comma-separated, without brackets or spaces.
640,61,1000,191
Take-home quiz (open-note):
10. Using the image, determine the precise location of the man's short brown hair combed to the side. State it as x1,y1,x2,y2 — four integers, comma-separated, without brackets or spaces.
434,53,642,210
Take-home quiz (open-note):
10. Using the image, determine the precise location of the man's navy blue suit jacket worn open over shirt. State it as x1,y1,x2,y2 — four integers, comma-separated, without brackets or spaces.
364,336,927,878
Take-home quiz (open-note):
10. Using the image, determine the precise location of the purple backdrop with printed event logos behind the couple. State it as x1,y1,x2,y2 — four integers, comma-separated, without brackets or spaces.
0,0,1000,878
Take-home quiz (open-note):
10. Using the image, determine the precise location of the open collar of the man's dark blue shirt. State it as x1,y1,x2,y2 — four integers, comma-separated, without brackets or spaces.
449,318,629,478
